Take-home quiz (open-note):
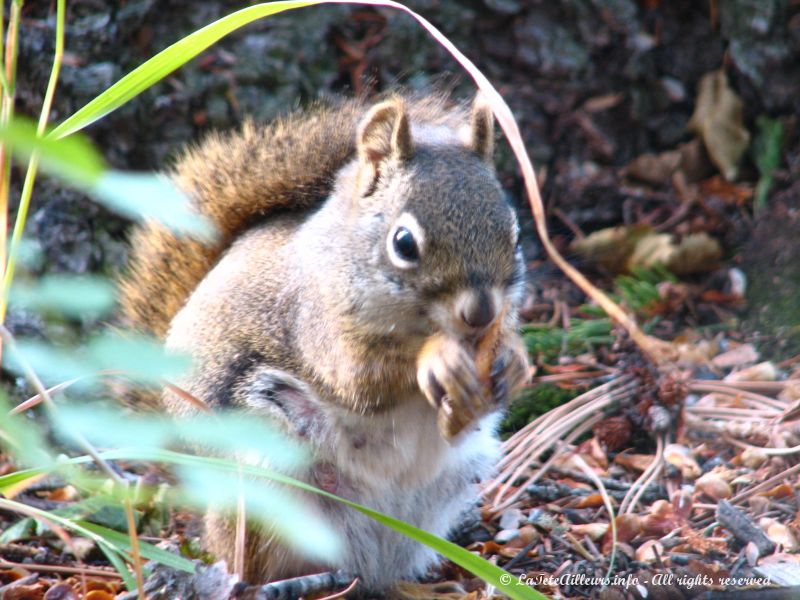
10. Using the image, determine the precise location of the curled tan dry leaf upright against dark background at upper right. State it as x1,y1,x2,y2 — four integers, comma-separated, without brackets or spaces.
689,70,750,181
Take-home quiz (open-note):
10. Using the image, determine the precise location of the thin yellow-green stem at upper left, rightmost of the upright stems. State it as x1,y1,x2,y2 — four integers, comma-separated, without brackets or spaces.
0,0,66,323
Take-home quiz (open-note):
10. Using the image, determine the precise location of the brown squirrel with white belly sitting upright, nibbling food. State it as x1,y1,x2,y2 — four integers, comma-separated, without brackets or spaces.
120,94,528,591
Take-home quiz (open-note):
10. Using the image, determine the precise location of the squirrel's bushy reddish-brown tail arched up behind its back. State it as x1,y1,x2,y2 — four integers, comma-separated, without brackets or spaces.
119,95,468,338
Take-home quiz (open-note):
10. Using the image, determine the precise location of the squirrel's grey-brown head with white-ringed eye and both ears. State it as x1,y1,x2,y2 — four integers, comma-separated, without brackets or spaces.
337,91,523,336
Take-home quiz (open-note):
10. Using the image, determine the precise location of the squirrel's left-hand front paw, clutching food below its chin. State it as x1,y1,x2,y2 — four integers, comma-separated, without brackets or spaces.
417,334,494,440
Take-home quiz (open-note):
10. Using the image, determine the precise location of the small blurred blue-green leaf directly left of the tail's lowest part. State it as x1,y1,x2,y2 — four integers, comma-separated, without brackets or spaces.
10,274,115,317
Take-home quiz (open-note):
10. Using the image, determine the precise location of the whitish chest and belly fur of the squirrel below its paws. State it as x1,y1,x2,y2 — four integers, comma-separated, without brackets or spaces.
316,397,499,587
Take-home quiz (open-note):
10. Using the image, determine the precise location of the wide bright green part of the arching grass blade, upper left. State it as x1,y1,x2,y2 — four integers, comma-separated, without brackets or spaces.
49,0,320,138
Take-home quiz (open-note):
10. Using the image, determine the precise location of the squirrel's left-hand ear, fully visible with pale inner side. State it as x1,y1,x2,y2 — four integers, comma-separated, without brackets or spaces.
356,98,414,195
